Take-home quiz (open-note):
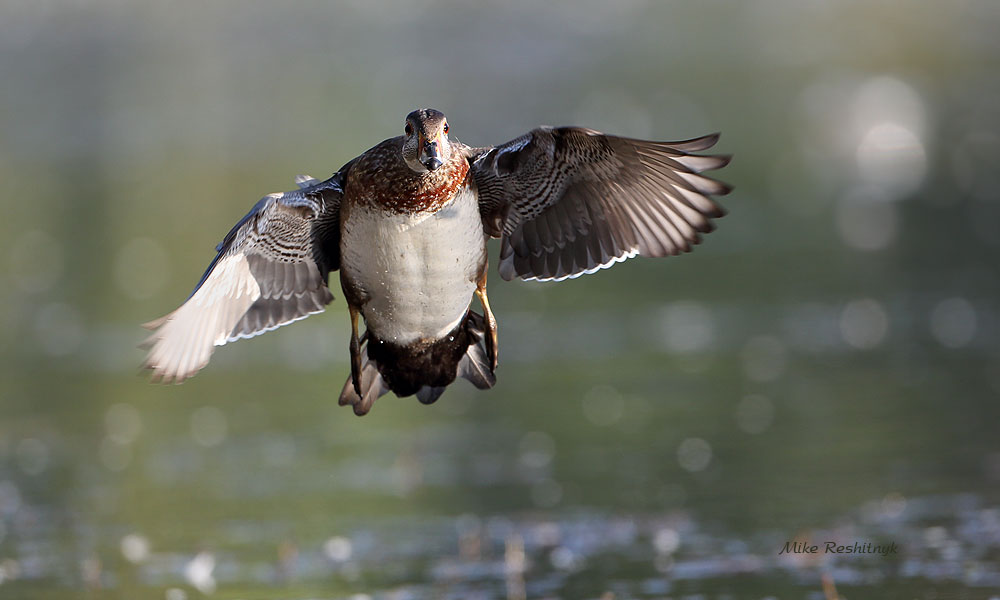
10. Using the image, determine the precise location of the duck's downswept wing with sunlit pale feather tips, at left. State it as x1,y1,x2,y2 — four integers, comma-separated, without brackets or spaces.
143,169,346,383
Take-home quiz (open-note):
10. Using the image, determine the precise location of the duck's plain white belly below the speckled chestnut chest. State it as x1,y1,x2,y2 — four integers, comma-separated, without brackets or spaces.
340,188,486,344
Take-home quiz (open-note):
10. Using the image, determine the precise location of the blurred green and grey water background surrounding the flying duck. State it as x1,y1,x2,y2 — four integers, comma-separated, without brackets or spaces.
0,0,1000,600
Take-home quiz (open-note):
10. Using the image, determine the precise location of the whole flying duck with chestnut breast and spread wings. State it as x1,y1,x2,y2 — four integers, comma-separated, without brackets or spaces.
145,109,730,415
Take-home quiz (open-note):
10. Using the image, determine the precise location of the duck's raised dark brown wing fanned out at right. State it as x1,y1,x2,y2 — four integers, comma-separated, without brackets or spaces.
471,127,730,281
